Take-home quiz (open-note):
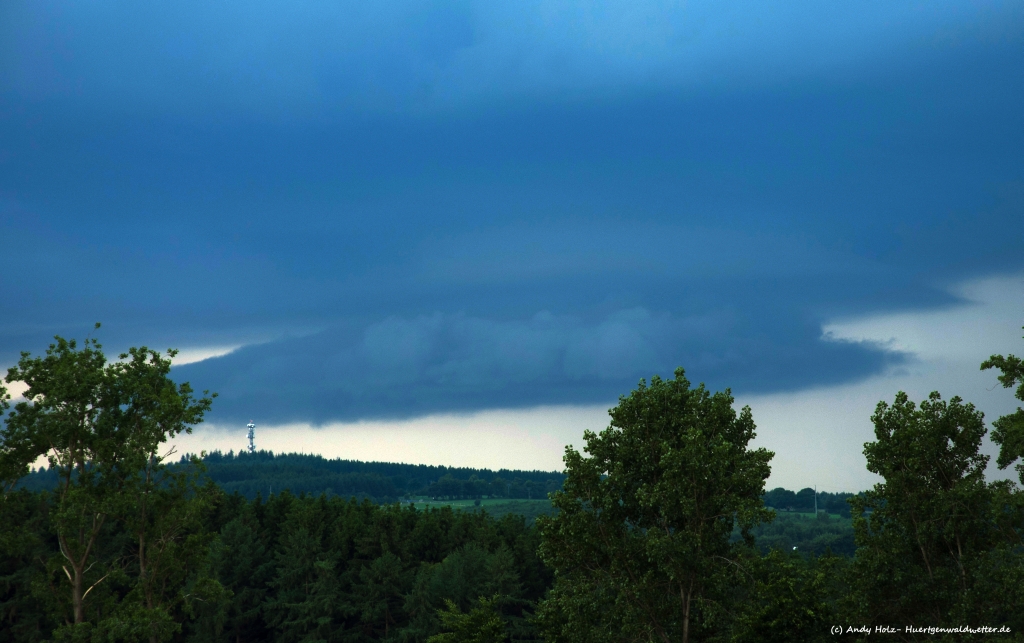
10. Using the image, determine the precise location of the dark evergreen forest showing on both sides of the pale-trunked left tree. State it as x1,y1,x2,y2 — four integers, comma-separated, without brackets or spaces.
0,490,552,641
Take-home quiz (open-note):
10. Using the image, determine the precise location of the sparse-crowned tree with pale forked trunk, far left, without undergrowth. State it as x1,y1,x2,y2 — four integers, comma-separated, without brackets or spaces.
0,331,212,638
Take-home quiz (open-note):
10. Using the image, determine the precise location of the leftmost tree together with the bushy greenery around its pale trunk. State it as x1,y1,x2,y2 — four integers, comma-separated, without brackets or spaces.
0,331,218,641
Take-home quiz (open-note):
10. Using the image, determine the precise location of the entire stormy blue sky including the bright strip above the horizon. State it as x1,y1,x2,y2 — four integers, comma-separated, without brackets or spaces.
0,0,1024,490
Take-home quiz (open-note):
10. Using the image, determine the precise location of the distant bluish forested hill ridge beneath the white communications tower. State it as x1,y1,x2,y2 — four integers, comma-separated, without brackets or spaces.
20,451,564,503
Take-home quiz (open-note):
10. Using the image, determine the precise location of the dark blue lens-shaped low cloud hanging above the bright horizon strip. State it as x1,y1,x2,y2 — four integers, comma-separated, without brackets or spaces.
174,308,905,424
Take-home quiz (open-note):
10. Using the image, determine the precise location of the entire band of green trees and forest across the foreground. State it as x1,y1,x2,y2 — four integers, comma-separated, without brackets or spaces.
0,323,1024,643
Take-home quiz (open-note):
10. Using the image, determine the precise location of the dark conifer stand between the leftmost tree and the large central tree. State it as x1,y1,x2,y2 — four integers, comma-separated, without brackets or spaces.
173,494,551,642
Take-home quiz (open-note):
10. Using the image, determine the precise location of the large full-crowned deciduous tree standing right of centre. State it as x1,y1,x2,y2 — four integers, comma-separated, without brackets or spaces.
539,369,772,643
